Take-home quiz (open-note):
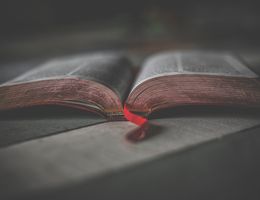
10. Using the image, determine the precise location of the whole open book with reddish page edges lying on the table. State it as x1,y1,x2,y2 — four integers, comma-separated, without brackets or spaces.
0,51,260,120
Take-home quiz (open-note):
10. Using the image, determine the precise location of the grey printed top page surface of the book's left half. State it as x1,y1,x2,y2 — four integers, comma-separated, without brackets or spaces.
4,53,133,99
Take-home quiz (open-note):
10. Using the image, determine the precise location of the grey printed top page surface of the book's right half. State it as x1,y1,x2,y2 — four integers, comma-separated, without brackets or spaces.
134,51,257,88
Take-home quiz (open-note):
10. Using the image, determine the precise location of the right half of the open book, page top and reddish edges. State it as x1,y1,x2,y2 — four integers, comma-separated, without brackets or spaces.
126,51,260,115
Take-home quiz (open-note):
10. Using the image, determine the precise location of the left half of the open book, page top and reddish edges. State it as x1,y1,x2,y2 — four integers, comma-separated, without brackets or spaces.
0,52,134,116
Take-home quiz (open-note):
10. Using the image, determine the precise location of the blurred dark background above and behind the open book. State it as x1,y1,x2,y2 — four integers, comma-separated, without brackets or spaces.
0,0,260,62
